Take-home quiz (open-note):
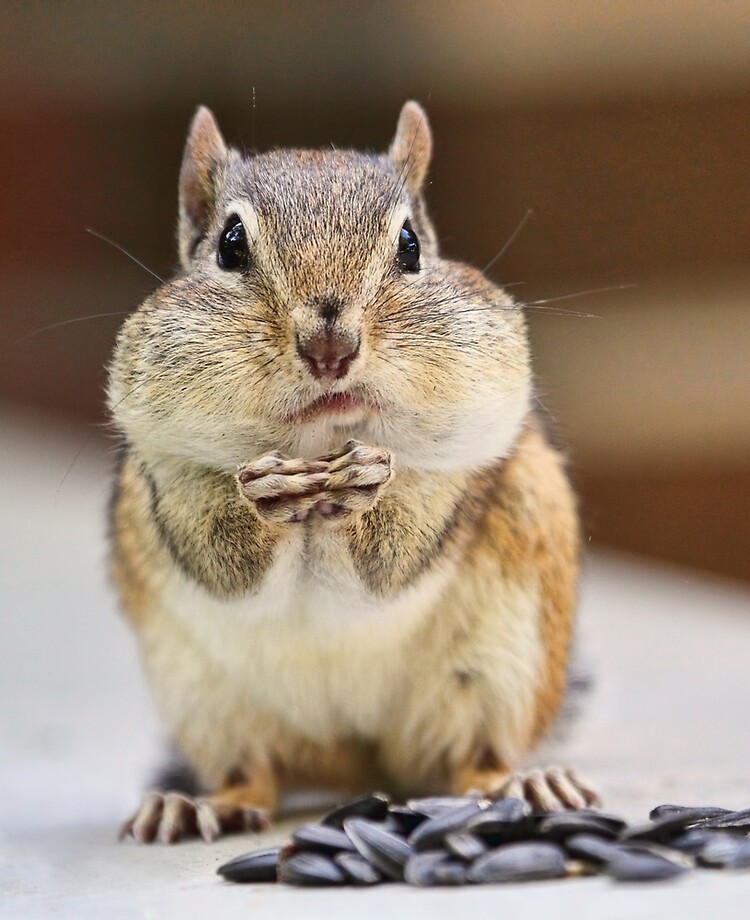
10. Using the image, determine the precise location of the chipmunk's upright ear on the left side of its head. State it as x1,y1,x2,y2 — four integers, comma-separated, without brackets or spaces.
178,106,228,268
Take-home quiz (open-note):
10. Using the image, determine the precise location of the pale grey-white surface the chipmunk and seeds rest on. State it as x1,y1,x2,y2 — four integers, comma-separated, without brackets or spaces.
0,409,750,920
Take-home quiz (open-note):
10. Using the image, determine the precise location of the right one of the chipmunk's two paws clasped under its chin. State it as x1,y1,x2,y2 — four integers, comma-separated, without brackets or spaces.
315,441,393,518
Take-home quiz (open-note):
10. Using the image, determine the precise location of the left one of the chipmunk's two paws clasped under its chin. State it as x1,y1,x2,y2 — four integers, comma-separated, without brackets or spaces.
236,454,328,524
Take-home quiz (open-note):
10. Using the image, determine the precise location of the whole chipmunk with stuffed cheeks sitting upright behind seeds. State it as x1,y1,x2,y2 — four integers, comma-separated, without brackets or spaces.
108,102,595,842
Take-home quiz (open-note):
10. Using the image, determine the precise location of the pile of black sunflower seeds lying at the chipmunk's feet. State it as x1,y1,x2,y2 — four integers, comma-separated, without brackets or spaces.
218,792,750,886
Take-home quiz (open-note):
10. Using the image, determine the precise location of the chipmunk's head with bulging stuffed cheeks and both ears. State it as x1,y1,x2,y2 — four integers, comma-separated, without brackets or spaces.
109,102,530,470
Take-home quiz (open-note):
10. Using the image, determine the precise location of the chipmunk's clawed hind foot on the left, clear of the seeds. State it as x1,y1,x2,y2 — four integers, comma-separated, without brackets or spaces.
120,792,271,843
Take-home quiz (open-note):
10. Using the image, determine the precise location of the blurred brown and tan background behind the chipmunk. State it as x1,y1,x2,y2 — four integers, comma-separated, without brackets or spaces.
0,0,750,579
